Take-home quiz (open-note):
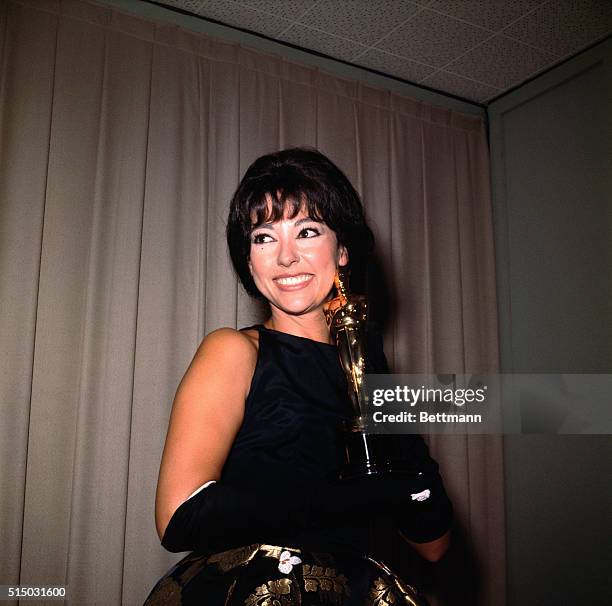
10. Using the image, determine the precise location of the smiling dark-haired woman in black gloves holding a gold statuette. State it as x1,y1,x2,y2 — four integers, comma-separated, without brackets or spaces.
146,149,451,606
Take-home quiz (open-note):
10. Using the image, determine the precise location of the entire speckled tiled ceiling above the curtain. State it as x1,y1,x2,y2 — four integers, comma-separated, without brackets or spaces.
155,0,612,105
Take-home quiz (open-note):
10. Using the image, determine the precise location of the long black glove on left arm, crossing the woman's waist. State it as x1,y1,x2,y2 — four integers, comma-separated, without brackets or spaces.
162,476,452,553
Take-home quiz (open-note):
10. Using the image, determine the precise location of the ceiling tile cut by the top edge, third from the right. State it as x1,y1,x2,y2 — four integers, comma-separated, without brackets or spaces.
300,0,421,45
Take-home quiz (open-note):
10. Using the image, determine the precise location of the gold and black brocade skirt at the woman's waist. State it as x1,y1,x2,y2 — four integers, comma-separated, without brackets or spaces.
145,544,427,606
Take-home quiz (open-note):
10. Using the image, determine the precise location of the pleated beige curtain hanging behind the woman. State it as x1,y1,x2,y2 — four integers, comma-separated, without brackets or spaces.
0,0,505,606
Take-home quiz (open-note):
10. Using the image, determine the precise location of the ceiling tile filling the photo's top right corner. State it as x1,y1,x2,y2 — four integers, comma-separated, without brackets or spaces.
504,0,612,58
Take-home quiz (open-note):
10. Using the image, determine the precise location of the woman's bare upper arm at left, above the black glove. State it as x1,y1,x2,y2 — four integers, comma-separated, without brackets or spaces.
155,328,257,539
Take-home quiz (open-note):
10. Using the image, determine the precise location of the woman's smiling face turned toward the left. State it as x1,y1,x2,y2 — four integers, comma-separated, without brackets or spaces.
249,200,348,315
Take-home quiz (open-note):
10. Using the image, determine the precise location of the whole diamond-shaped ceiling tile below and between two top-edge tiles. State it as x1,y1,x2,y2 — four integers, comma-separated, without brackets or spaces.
376,9,491,67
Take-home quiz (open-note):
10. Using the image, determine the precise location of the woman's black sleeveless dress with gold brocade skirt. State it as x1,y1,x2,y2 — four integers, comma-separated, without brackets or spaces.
145,325,426,606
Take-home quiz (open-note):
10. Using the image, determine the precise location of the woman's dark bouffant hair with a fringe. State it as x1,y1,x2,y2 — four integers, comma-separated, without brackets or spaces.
227,147,374,298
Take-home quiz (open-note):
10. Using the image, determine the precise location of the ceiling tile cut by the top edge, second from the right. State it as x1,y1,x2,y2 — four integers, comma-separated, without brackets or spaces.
429,0,543,31
